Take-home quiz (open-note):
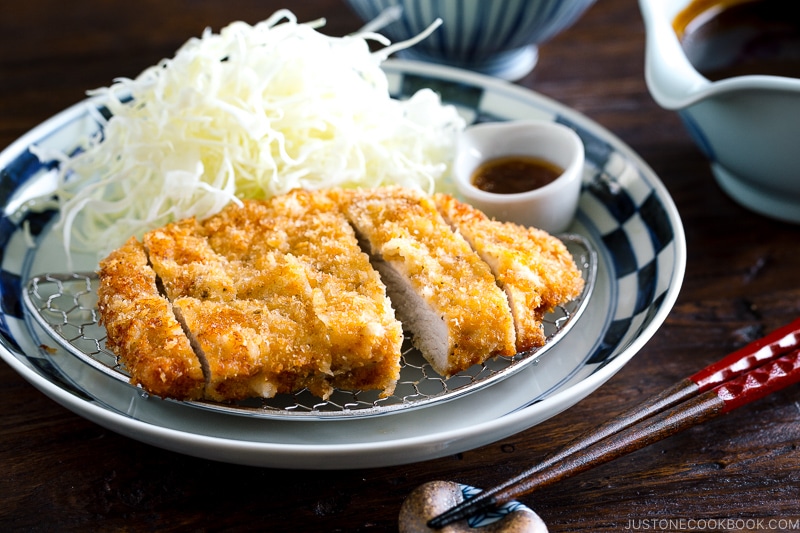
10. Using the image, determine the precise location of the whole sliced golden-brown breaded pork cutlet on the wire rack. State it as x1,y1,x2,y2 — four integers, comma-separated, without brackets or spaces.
98,186,583,401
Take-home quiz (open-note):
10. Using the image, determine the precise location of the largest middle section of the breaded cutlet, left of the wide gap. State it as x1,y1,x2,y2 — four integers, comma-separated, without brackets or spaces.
140,192,402,400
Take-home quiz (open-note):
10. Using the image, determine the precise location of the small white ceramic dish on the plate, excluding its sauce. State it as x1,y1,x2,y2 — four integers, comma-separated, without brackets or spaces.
453,120,585,234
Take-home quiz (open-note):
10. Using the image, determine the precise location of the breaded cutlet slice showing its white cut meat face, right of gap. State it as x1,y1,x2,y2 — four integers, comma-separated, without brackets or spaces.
330,187,515,376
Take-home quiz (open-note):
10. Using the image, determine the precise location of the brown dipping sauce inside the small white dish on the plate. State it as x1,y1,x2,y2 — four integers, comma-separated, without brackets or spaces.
470,155,564,194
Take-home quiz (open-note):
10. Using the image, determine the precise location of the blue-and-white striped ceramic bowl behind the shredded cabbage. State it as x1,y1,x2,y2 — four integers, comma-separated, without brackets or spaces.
347,0,595,80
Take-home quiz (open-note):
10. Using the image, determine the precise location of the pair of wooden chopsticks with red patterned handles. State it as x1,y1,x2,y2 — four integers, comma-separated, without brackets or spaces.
428,318,800,529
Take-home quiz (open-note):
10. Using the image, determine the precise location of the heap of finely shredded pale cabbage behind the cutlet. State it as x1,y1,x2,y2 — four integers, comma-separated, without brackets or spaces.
34,10,464,260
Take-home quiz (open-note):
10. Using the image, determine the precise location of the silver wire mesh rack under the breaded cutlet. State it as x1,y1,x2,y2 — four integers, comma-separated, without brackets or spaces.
22,234,598,420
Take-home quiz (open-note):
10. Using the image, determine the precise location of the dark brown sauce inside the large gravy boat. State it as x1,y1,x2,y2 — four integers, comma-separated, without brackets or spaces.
672,0,800,81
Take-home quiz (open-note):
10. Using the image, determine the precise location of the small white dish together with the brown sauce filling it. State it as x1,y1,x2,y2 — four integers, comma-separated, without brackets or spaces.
453,120,584,233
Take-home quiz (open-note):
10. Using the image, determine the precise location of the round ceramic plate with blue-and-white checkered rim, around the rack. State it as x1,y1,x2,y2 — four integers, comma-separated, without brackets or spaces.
0,57,685,468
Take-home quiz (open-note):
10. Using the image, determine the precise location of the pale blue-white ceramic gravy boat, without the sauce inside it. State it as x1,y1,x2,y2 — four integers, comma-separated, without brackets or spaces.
639,0,800,223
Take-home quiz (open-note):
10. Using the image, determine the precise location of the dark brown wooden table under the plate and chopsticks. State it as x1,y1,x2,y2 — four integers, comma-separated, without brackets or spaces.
0,0,800,532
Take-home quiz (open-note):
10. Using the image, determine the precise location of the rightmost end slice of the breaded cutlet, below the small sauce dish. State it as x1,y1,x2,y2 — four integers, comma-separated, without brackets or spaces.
434,194,584,352
